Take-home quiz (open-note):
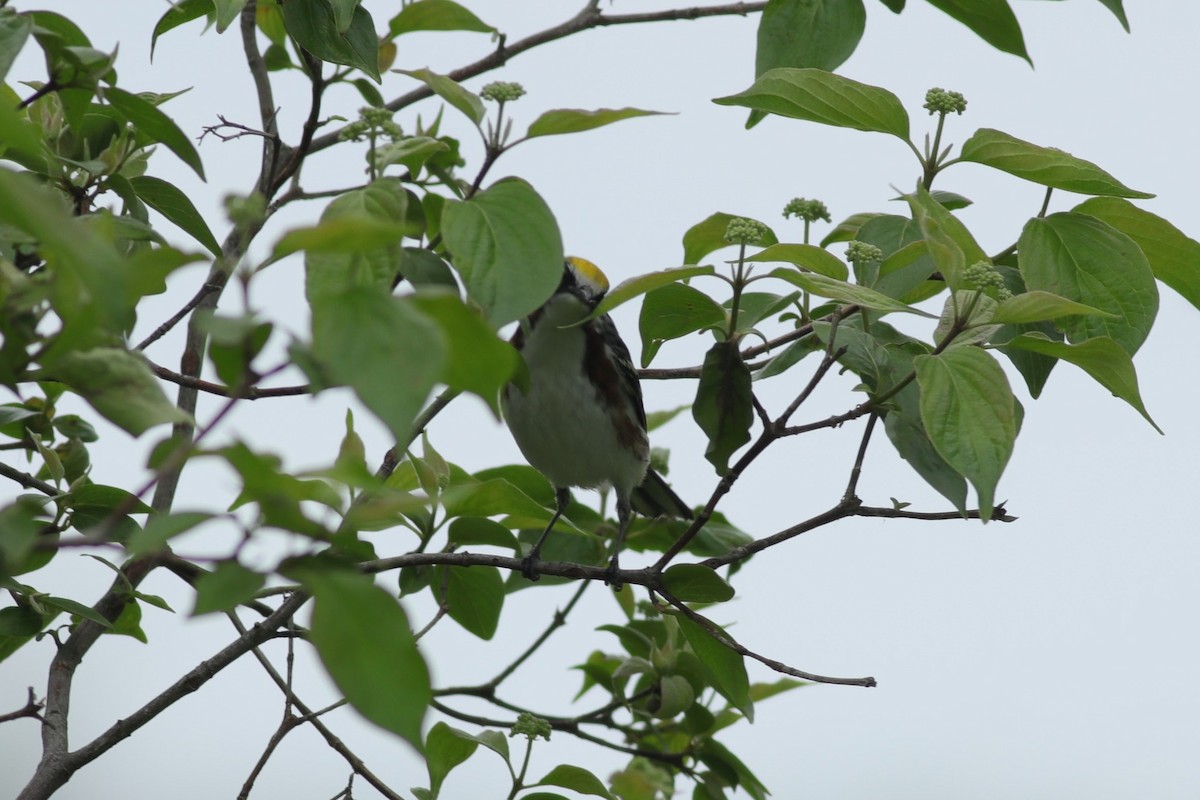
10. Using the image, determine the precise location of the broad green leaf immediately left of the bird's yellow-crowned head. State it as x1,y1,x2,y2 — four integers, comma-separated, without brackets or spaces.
442,178,564,326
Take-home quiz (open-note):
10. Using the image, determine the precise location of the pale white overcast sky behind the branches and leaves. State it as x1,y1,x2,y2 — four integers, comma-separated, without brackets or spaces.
0,0,1200,800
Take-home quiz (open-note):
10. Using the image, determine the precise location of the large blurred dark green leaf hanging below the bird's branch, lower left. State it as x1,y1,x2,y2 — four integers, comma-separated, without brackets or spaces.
280,559,432,750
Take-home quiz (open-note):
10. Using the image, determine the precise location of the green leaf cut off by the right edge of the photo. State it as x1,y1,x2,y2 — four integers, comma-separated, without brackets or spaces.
1073,197,1200,308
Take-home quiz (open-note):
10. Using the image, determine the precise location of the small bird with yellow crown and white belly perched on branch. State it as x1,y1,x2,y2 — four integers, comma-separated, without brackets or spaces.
500,255,692,589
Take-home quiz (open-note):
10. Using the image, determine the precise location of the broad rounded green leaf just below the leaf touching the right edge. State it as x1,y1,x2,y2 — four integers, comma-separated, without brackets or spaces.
1018,211,1158,355
